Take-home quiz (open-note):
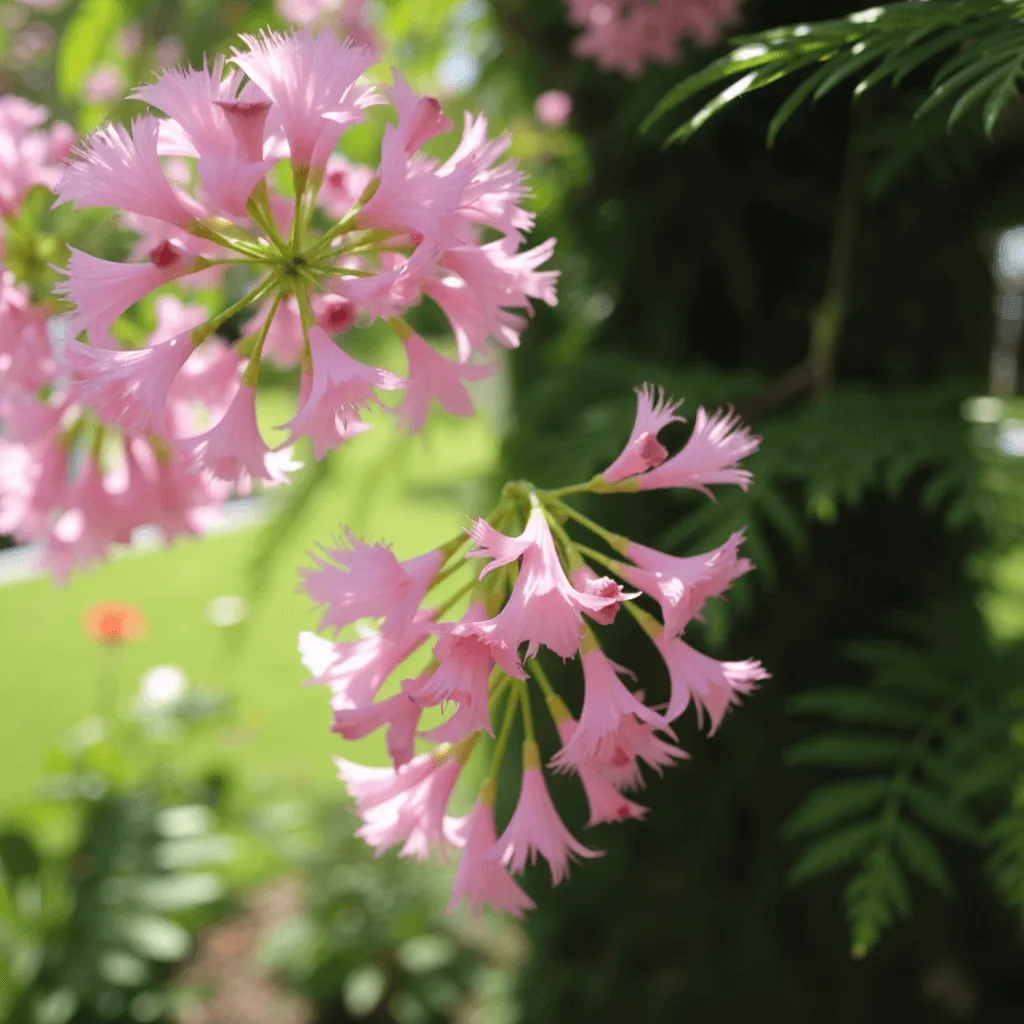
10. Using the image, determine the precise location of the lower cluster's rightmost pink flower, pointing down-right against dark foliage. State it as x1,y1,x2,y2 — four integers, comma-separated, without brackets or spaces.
653,631,771,735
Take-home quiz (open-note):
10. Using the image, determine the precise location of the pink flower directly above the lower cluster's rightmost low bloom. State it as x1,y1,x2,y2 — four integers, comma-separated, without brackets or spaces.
615,529,754,635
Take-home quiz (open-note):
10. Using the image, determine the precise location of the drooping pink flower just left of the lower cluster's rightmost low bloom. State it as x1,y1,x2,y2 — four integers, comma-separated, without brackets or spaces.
551,648,669,768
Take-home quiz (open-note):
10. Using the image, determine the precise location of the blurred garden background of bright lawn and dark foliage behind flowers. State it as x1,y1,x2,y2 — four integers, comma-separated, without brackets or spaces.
6,0,1024,1024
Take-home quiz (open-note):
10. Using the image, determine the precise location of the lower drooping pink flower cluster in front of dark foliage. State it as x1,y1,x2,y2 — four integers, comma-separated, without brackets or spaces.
299,388,767,915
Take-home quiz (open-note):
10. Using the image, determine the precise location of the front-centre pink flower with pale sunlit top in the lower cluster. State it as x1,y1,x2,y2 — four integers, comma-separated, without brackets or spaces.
466,508,622,657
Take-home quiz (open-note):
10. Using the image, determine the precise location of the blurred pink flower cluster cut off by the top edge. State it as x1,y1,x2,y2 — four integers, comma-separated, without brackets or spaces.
567,0,739,78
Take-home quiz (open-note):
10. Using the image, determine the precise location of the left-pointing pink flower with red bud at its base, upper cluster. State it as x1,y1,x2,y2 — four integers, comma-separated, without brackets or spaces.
54,244,197,345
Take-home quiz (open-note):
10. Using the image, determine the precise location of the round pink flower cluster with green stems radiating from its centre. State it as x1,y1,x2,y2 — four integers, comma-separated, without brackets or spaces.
56,29,557,485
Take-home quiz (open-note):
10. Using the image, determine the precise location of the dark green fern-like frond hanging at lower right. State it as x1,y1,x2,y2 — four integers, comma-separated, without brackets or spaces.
783,602,1024,957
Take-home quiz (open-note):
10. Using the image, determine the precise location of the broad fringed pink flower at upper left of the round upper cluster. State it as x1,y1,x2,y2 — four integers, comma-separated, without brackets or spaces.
54,115,203,227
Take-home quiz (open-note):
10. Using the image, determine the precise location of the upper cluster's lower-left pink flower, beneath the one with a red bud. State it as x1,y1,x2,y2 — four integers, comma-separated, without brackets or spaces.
63,332,195,437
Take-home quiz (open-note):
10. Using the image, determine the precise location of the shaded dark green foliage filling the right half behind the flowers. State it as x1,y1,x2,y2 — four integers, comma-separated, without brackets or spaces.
489,0,1024,1024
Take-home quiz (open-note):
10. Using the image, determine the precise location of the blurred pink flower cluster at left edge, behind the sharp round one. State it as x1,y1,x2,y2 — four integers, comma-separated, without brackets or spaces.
0,299,234,581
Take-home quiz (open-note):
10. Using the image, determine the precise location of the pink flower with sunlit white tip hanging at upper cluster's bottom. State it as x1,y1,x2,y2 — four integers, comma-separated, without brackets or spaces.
178,384,301,490
